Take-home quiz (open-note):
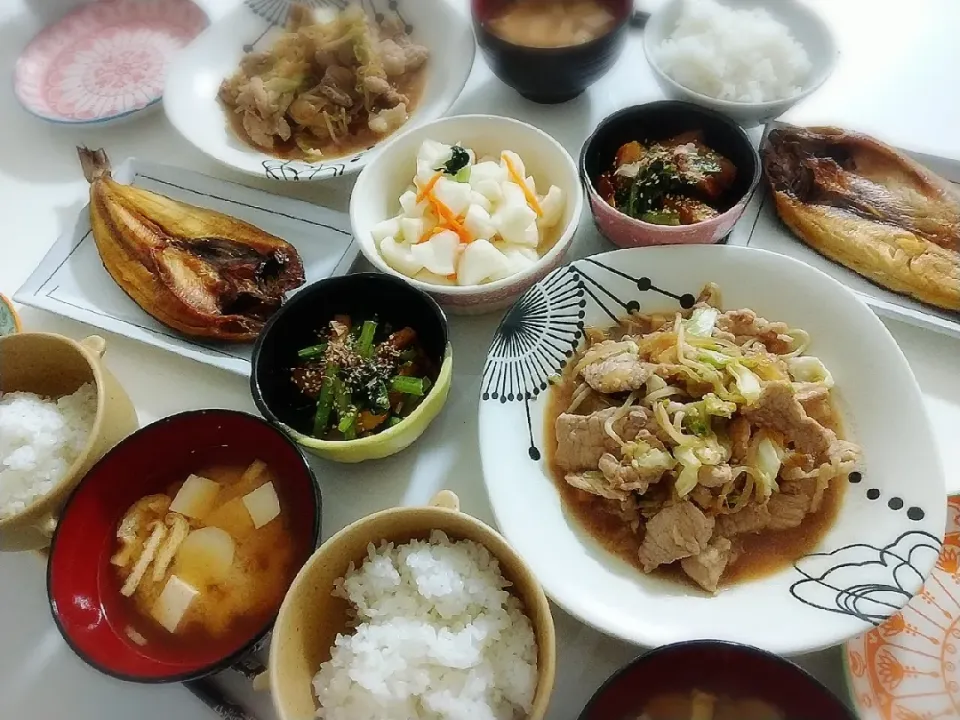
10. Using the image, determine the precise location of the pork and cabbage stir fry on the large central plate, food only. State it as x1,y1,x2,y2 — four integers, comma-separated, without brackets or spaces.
554,285,860,591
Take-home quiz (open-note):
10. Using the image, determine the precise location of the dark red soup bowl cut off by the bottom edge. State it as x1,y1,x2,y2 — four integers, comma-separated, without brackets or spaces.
579,640,856,720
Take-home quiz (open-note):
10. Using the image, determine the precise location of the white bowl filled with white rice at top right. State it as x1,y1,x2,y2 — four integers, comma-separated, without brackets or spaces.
643,0,839,127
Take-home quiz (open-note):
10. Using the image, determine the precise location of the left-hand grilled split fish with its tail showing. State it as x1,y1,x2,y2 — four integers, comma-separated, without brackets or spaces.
77,148,304,342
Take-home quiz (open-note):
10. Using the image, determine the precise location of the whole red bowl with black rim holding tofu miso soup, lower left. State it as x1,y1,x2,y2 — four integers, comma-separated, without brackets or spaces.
47,410,320,682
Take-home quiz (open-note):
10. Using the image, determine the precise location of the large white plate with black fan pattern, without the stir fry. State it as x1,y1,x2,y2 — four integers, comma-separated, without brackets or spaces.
480,246,946,655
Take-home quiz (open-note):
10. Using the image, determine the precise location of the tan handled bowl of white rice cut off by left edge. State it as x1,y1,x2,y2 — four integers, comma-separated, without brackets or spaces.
0,333,138,550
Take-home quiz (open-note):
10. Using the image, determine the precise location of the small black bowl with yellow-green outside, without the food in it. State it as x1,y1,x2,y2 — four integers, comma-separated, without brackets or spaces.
250,272,453,463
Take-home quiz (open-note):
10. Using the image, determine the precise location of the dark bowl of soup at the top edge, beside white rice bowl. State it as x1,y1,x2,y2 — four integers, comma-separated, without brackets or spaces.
472,0,633,103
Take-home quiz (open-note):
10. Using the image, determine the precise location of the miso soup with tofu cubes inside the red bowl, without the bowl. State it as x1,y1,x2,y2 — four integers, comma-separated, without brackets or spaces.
110,460,309,655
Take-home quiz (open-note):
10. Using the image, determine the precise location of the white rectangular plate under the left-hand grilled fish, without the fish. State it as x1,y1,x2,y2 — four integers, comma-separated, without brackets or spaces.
14,158,358,375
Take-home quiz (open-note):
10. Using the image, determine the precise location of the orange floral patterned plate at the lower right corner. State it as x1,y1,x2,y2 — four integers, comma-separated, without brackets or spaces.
845,496,960,720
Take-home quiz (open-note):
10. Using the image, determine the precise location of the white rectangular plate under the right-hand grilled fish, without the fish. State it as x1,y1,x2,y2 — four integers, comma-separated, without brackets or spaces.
730,123,960,338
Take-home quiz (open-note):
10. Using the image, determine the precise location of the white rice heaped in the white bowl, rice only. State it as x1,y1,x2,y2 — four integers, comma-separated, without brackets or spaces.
655,0,812,103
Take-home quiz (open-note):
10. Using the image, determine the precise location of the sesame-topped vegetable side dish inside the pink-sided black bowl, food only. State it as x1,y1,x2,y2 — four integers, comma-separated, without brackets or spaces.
597,132,737,225
